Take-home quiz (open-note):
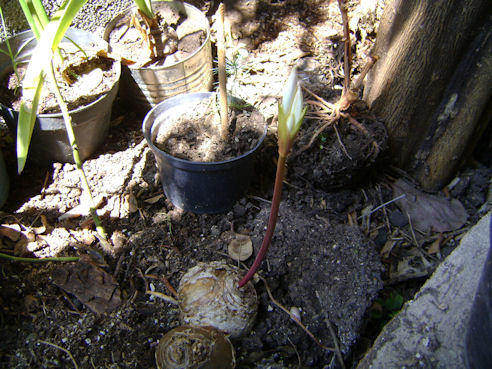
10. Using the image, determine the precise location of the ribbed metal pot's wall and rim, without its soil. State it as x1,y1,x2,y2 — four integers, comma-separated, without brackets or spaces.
103,1,213,113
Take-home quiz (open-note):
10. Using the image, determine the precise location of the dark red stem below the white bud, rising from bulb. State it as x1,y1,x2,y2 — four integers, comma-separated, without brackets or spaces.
238,155,287,288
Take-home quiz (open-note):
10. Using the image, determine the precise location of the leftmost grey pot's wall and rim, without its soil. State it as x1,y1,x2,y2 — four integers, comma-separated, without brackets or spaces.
0,28,121,165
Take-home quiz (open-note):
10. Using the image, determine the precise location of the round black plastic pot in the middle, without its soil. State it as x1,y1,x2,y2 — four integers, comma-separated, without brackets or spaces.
142,92,266,214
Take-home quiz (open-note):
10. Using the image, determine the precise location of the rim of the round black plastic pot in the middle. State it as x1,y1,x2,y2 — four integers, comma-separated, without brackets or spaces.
142,92,268,167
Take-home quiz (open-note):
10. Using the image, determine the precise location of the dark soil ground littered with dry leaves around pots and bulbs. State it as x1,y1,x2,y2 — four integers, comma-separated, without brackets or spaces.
0,1,491,368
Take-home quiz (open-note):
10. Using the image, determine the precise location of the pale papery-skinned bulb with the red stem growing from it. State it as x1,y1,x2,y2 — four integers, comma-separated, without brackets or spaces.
178,261,258,338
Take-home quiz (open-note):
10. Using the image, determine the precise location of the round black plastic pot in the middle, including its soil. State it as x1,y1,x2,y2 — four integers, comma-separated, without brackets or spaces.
142,92,266,214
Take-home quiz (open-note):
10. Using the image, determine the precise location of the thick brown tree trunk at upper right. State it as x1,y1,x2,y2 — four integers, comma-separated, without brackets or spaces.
364,0,492,191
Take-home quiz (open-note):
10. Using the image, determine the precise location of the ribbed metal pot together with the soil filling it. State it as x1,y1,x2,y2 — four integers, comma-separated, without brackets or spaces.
104,1,213,113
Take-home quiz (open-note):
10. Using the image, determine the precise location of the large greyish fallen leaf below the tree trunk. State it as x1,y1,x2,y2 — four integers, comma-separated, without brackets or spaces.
393,179,468,233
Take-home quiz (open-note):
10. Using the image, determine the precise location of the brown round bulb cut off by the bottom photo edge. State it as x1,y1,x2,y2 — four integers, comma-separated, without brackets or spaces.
155,326,235,369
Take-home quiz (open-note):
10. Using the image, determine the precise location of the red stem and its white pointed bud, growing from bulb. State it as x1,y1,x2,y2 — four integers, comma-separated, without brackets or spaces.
238,68,307,288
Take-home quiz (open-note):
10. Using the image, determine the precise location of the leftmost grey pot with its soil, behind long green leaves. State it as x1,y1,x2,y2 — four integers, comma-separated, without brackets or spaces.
0,28,121,165
